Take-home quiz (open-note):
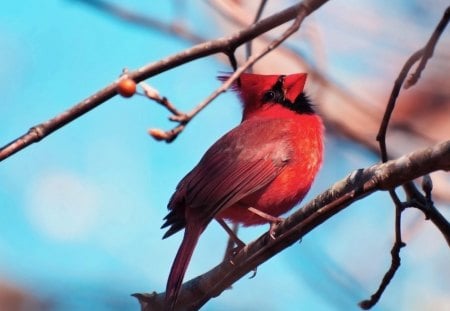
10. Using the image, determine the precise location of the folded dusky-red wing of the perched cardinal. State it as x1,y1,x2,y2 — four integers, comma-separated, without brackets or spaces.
163,120,290,237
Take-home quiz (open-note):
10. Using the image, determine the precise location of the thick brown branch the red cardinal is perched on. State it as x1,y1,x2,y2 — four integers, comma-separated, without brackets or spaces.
135,141,450,311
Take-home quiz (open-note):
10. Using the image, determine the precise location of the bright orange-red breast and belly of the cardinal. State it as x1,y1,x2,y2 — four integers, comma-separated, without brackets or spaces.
218,115,323,226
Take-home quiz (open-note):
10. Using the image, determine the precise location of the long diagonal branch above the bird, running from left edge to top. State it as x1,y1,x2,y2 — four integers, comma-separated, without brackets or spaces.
0,0,327,165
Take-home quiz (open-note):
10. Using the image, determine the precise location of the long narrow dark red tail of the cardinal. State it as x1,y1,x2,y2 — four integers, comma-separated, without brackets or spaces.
165,224,203,310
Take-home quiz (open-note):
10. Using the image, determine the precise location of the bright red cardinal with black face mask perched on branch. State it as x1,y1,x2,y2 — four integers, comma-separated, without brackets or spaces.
162,73,323,310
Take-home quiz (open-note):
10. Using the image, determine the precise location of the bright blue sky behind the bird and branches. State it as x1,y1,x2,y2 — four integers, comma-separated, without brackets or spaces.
0,0,448,310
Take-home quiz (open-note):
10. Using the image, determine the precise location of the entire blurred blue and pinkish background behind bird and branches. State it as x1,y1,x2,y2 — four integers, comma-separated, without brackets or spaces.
0,0,450,311
